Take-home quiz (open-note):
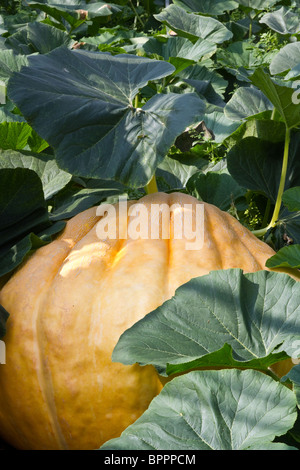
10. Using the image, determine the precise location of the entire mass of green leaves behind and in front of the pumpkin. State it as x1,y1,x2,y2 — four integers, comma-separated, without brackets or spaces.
0,0,300,450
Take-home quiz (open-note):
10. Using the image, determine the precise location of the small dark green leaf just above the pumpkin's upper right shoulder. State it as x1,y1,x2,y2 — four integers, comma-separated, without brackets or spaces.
186,172,246,211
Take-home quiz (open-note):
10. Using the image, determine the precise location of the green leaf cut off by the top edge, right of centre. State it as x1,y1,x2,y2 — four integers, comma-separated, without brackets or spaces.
173,0,238,16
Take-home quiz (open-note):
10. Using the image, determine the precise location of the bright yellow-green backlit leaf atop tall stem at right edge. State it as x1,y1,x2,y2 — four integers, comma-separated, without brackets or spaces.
250,68,300,129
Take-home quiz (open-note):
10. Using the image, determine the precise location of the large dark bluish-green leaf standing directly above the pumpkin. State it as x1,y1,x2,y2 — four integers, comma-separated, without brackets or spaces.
8,48,204,187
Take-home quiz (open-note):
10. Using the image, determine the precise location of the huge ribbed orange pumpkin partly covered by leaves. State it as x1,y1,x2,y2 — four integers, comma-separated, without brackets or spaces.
0,193,296,449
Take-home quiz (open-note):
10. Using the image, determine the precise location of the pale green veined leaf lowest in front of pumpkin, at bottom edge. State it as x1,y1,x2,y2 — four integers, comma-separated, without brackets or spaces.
100,370,297,451
